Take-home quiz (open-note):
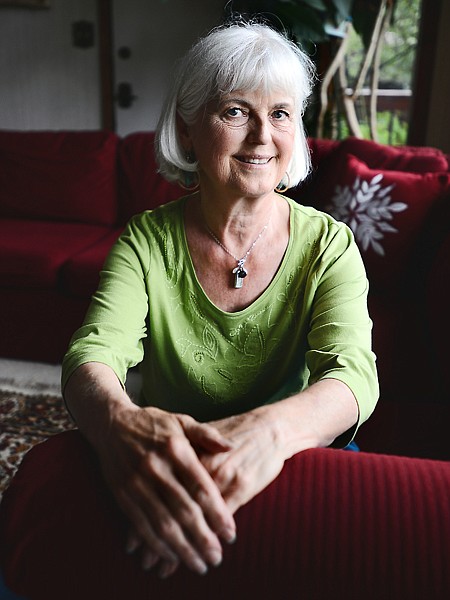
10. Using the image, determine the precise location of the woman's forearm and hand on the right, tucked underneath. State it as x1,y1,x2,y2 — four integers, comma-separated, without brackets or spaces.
202,379,358,513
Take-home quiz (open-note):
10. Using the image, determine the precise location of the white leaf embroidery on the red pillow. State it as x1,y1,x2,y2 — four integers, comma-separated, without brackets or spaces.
325,173,408,256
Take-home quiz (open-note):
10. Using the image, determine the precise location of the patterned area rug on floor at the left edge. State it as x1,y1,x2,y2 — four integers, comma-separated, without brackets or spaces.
0,391,74,499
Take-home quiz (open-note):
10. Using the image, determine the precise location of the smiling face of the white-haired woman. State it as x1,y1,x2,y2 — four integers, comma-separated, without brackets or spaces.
181,91,297,198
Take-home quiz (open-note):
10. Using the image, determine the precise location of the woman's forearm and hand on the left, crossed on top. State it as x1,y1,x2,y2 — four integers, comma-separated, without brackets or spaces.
64,363,239,575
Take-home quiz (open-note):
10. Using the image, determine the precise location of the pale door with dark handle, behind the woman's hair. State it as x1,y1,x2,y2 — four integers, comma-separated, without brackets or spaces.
105,0,225,135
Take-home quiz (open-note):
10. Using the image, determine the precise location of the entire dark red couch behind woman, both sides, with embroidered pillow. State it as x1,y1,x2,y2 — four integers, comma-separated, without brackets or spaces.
0,131,450,459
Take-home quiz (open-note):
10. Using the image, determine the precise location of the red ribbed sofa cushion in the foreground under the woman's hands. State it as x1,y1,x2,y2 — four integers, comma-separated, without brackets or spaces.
0,431,450,600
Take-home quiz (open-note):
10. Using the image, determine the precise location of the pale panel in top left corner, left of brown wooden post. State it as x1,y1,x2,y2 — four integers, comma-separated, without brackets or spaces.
0,0,101,130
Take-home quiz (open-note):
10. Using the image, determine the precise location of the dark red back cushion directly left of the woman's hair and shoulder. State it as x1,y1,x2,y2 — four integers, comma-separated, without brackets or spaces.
119,132,187,222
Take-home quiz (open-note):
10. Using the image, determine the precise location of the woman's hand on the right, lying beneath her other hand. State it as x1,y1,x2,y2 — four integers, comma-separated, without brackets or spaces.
201,407,287,513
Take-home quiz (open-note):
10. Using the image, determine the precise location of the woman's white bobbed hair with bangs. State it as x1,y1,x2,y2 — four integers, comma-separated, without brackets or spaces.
155,23,315,187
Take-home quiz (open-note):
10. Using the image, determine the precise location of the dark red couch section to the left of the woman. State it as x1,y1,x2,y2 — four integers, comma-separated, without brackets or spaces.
0,131,179,363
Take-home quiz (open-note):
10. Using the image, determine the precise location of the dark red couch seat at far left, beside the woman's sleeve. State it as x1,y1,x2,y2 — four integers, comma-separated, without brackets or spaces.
0,219,110,288
